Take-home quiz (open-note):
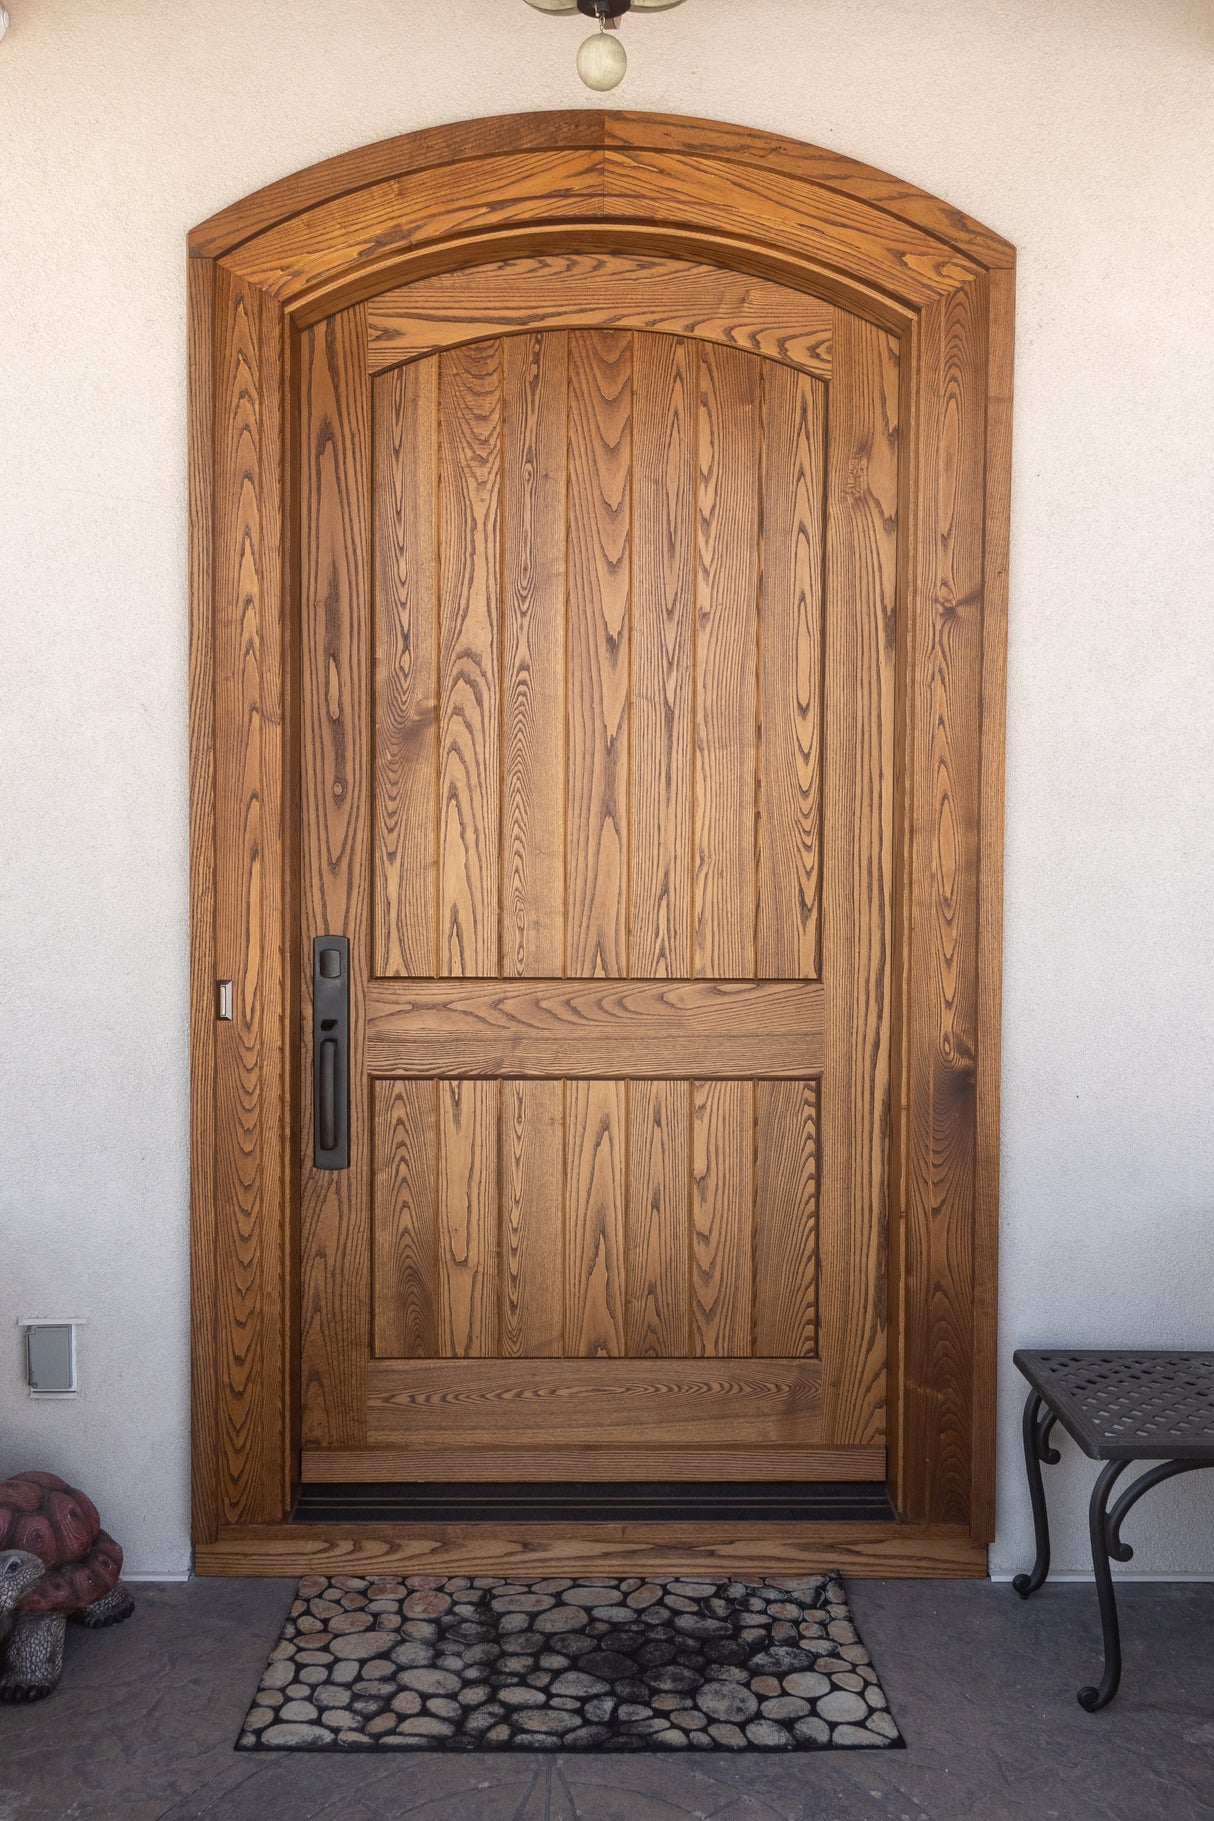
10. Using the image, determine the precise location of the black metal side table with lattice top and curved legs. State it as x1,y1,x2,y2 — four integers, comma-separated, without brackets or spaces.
1012,1349,1214,1714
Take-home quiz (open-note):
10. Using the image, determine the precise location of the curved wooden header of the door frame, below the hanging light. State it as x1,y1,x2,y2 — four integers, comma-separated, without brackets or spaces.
191,115,1012,328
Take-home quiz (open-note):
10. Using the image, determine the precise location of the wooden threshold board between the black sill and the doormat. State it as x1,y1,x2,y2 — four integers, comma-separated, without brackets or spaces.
195,1522,986,1581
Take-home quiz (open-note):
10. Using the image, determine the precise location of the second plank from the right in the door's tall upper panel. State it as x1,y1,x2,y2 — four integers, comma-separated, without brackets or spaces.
693,346,761,980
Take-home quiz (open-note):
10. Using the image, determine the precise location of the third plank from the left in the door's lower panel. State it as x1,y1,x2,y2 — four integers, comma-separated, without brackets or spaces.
501,1082,564,1358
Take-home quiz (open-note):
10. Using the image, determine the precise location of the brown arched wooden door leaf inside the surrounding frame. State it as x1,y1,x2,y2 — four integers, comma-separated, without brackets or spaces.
298,255,899,1479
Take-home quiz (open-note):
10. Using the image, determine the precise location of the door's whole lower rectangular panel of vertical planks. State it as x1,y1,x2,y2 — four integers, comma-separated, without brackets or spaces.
373,1078,830,1369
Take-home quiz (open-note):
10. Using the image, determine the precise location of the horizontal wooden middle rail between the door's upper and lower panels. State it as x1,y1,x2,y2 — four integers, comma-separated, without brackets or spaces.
366,980,826,1080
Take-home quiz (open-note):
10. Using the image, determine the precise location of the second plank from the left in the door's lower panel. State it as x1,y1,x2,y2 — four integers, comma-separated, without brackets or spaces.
437,1082,499,1358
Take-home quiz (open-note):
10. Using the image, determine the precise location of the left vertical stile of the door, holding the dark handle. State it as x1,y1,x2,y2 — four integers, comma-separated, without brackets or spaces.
298,306,371,1448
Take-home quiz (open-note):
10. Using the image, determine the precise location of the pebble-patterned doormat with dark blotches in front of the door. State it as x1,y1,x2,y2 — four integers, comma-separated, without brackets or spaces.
237,1575,903,1752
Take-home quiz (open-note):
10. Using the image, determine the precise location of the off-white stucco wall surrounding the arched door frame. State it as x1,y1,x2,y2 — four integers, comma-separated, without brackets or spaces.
0,0,1214,1573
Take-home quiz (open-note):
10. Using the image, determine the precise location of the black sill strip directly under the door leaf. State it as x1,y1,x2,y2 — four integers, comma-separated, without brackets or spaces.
289,1480,894,1526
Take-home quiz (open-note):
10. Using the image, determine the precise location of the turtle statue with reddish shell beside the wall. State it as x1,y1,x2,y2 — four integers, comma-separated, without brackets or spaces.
0,1473,135,1701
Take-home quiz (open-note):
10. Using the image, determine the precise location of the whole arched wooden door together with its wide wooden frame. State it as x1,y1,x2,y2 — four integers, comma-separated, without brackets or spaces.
195,117,1007,1570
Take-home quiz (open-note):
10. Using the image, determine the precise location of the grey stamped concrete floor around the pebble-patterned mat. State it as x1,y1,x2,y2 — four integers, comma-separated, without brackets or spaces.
0,1581,1214,1821
